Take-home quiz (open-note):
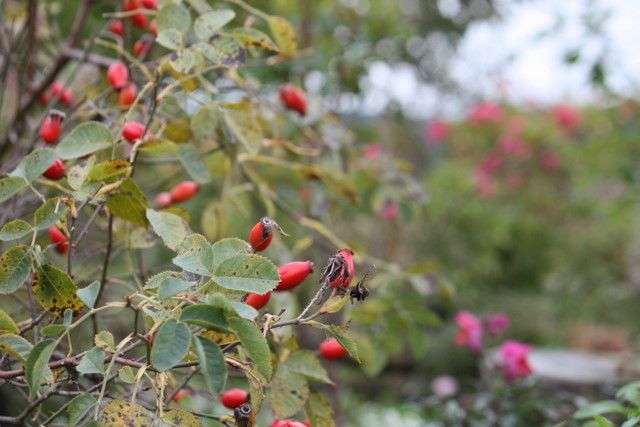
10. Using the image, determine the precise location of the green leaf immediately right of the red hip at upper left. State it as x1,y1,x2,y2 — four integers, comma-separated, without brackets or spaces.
56,122,113,160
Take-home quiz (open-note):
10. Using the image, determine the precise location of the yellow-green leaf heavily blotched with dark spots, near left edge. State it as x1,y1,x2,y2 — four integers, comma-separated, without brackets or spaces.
33,264,84,315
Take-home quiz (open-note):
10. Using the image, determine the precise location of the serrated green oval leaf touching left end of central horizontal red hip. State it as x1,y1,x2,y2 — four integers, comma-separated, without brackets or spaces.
213,254,280,295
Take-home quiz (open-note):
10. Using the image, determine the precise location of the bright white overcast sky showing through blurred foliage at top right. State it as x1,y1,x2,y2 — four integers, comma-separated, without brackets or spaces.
364,0,640,118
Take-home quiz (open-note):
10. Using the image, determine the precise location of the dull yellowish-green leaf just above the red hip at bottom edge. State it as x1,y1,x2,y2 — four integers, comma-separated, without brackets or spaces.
271,365,309,418
